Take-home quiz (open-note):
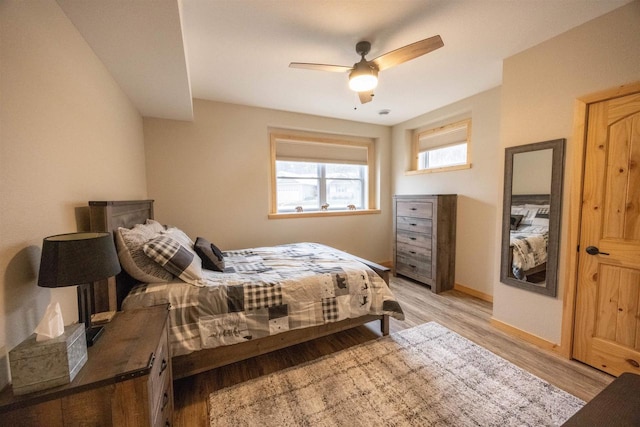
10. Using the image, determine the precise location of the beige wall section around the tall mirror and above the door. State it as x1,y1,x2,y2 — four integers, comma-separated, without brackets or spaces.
493,1,640,343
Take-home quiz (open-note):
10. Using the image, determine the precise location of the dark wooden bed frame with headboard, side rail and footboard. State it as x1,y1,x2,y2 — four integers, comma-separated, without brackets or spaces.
89,200,390,379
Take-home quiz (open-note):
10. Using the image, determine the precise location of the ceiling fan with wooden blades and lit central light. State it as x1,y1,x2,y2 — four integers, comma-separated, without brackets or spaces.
289,35,444,104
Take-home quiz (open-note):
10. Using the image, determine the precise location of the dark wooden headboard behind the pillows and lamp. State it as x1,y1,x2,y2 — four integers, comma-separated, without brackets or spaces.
89,200,153,312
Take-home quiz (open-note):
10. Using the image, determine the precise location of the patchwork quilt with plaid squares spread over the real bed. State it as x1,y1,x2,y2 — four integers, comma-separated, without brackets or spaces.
122,243,404,356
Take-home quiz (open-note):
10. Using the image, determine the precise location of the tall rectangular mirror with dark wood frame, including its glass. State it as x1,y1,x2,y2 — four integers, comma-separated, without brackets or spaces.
500,139,565,297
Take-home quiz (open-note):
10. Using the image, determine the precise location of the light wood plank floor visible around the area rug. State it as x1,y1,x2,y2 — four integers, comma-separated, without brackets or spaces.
174,277,613,427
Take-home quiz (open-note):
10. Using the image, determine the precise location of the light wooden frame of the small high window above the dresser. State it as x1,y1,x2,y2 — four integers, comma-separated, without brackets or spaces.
408,119,472,174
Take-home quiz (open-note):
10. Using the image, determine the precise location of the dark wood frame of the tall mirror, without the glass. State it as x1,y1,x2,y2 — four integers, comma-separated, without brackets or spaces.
500,138,566,297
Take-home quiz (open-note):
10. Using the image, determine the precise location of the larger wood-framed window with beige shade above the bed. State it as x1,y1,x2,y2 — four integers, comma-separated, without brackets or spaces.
271,133,375,215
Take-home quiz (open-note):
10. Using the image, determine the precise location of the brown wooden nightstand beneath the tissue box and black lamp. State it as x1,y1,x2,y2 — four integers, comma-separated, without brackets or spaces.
0,305,173,427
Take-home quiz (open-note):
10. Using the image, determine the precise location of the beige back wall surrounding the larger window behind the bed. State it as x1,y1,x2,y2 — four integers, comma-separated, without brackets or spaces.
144,100,391,262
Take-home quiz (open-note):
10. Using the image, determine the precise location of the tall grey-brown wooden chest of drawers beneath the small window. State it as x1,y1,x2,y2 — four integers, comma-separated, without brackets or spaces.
393,194,458,293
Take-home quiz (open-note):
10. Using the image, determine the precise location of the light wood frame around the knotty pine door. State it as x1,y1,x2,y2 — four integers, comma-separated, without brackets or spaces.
557,81,640,359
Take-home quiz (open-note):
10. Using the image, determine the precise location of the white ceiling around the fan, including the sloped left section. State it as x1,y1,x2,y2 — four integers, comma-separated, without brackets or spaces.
57,0,632,125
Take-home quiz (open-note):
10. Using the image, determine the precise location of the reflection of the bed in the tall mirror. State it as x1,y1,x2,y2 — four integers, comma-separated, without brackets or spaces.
509,194,549,283
